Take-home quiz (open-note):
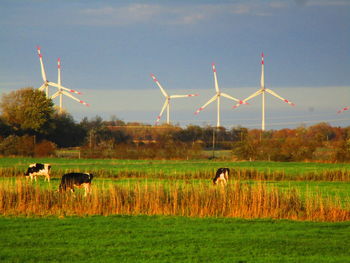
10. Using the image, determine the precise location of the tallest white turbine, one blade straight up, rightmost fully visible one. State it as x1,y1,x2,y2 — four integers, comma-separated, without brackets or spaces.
233,53,295,131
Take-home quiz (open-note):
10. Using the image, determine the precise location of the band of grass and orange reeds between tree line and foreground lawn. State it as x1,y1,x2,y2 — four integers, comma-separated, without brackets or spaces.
0,158,350,221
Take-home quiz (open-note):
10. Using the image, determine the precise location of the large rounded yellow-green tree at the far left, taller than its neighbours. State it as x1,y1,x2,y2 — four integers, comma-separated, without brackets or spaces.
0,88,54,134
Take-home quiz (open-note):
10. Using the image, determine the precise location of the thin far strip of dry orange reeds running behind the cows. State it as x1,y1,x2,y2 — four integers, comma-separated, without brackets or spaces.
0,168,350,182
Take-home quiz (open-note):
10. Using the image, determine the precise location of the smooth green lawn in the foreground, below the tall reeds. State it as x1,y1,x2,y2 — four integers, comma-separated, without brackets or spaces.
0,216,350,263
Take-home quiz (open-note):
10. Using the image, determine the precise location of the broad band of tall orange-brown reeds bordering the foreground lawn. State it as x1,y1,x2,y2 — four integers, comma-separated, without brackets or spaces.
0,179,350,222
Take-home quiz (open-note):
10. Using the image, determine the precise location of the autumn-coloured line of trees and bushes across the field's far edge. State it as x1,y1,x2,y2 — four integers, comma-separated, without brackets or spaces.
0,88,350,162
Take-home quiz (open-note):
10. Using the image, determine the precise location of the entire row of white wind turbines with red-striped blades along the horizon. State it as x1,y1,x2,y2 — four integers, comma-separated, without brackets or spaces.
37,46,350,131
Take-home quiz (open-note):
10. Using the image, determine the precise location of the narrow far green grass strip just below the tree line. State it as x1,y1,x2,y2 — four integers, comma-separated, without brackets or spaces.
0,157,350,175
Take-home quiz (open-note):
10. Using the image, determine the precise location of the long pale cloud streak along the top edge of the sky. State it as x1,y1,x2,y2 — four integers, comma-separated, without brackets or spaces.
77,3,278,26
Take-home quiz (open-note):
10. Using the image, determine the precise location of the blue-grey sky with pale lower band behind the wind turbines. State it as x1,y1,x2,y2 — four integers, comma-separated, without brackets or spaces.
0,0,350,129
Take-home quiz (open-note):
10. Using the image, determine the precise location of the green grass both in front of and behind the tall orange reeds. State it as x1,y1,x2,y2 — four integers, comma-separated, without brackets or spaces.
0,158,350,263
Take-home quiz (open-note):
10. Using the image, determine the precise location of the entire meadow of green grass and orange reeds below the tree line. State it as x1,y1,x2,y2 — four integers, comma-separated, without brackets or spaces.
0,158,350,262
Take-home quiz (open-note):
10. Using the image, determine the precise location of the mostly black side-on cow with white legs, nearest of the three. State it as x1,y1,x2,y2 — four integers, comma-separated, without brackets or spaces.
58,173,93,196
